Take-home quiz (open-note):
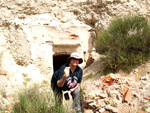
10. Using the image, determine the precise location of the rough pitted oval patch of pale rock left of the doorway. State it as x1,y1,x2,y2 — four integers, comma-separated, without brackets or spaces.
4,26,31,66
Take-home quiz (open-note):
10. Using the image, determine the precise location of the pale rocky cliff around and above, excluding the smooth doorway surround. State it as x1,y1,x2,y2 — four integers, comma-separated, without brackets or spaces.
0,0,150,112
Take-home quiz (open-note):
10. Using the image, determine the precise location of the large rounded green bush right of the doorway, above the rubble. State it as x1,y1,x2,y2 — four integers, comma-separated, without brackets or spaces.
95,16,150,73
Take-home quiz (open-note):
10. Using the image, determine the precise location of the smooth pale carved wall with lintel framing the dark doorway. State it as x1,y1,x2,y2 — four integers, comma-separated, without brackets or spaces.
24,25,95,76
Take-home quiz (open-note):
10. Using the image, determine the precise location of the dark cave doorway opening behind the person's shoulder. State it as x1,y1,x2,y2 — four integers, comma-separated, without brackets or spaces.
53,55,70,72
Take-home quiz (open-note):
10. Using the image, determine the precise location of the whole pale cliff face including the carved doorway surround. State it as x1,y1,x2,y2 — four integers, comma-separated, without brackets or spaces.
0,0,150,111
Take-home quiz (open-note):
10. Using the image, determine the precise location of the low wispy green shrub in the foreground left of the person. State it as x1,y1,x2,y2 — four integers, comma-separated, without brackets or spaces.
12,85,67,113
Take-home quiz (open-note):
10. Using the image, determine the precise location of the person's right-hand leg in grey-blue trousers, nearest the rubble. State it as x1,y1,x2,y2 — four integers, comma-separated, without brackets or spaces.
71,88,81,110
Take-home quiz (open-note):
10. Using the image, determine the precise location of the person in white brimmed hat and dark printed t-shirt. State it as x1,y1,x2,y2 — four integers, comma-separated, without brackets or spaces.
51,52,83,113
